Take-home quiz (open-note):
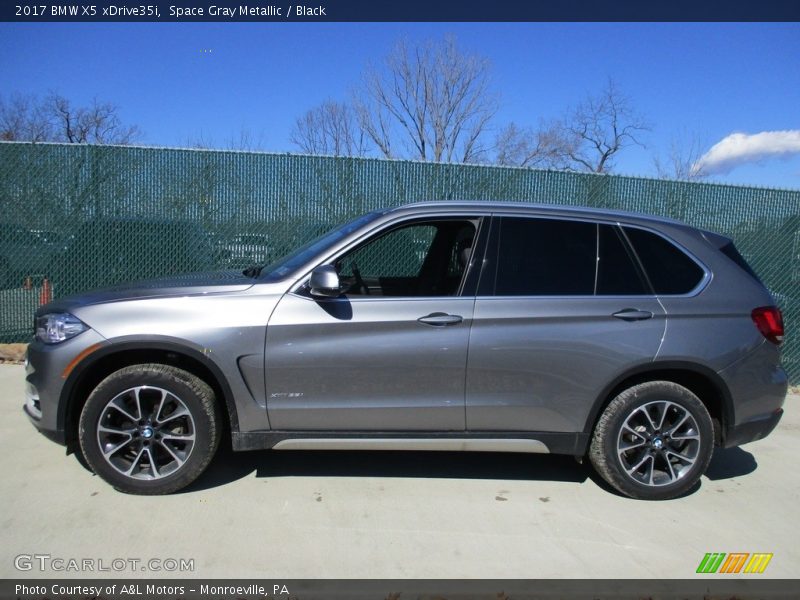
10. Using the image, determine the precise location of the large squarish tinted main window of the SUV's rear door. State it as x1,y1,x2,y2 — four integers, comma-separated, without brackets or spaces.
495,217,597,296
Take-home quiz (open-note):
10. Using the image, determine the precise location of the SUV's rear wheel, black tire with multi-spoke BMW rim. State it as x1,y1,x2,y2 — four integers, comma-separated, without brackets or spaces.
589,381,714,500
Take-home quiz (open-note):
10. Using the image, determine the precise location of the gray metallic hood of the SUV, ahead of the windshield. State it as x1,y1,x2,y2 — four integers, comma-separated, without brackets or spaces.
36,270,256,314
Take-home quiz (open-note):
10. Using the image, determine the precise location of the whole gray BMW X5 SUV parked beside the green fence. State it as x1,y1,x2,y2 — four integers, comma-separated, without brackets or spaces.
25,202,787,499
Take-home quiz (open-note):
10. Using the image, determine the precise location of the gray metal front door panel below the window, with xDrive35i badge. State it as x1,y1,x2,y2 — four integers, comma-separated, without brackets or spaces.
266,294,474,431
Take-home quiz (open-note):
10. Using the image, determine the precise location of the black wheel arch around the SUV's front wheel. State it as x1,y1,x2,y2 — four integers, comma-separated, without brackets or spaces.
58,340,239,453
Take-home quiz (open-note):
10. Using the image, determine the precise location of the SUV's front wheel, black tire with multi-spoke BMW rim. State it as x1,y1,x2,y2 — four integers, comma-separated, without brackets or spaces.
78,364,222,495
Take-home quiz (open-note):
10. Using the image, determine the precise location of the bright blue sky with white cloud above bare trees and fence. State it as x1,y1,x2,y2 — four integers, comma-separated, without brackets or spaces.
0,23,800,189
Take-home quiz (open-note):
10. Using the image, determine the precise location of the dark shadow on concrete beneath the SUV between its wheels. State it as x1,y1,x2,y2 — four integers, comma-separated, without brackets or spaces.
183,446,590,493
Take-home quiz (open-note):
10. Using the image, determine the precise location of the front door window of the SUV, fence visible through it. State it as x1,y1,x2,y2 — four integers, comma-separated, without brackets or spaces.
335,219,476,296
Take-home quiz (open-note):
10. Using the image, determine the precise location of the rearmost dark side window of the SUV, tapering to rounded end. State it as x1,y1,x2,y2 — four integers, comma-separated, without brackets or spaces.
625,227,703,294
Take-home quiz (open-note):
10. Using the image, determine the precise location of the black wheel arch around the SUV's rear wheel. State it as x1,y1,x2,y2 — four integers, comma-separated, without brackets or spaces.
583,361,734,445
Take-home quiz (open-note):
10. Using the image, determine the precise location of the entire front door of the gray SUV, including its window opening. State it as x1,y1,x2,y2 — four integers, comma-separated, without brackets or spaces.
265,217,479,431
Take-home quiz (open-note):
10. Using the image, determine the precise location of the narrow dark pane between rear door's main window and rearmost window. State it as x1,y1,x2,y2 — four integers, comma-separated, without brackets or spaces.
595,225,652,296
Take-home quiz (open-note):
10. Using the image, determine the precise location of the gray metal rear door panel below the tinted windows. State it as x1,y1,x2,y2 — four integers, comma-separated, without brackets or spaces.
466,297,666,431
